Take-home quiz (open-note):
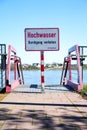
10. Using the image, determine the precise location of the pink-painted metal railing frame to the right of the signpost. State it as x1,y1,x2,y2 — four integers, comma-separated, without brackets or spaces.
60,45,83,91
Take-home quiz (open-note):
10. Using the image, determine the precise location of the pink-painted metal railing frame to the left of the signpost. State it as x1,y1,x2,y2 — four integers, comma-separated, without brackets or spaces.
6,45,24,92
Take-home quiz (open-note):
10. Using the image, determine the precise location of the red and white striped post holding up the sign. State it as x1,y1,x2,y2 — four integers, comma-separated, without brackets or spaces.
41,51,44,91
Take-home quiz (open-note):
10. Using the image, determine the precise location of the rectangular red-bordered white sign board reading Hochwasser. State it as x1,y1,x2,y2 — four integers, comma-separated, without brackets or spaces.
25,28,59,51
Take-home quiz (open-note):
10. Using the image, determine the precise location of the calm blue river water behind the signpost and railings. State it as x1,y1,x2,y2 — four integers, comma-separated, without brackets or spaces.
10,70,87,85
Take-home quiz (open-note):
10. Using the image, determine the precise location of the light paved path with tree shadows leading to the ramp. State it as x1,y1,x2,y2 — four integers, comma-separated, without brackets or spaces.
0,86,87,130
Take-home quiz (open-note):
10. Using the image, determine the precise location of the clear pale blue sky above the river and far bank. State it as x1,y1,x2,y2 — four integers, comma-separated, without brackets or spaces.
0,0,87,64
